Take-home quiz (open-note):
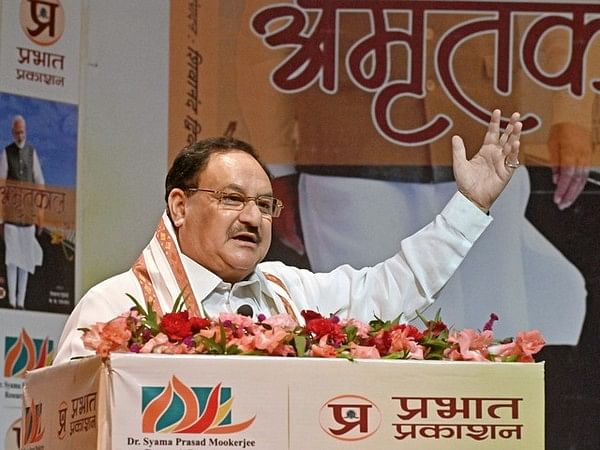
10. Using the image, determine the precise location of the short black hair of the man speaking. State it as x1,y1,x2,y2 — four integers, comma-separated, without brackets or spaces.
165,137,270,202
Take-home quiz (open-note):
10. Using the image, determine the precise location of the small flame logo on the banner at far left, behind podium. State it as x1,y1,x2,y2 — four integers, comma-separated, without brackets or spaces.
4,329,53,378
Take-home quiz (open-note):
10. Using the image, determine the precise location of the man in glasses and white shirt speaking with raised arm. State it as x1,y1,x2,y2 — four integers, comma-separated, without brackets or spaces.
55,110,522,363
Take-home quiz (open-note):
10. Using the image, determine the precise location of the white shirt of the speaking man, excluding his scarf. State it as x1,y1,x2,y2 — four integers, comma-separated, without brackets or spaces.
55,193,492,363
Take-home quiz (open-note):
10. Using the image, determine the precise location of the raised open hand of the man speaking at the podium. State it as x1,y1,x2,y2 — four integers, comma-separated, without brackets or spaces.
452,109,523,213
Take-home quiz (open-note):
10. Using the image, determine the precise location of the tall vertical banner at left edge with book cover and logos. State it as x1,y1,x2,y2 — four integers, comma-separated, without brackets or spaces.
0,0,82,450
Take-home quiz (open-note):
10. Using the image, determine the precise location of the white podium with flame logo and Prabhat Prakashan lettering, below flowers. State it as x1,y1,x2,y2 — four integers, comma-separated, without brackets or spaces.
21,353,544,450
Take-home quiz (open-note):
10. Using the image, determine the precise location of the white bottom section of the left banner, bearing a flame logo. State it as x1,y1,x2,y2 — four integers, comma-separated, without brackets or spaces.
0,310,66,450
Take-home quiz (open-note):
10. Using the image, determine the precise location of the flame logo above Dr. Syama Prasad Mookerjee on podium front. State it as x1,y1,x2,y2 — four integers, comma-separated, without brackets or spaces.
142,375,256,434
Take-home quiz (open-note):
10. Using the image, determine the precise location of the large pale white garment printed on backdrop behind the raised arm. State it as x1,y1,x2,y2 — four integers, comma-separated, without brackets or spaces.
299,169,586,345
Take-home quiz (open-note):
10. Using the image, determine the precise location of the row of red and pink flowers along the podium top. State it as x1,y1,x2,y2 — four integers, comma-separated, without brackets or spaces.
80,295,545,362
